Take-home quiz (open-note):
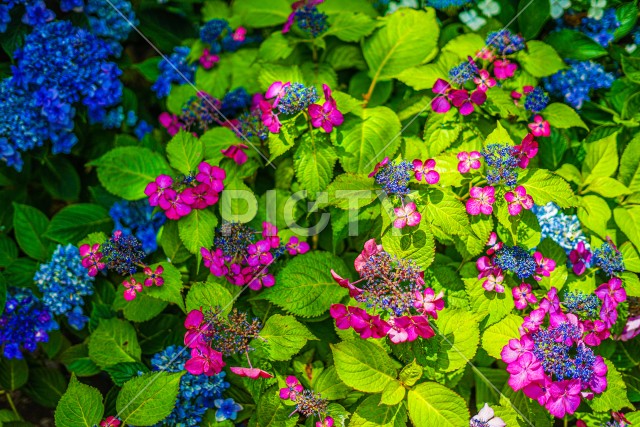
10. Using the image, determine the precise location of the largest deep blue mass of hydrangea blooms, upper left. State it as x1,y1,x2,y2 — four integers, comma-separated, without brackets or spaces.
0,21,122,170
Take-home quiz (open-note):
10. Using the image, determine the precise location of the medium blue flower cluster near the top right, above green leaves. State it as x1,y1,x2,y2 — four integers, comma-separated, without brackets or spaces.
543,60,615,109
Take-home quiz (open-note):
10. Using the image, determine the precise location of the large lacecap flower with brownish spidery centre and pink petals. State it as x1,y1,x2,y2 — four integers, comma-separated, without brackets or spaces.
330,239,444,344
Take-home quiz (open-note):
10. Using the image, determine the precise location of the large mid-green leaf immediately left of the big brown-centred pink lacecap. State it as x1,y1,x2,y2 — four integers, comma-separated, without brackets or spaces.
258,251,348,317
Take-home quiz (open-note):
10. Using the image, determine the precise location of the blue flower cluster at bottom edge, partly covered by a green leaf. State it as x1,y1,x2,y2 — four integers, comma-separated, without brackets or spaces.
151,346,230,427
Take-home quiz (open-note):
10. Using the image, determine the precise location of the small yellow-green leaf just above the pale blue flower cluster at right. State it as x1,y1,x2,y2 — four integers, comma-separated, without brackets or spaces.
519,169,578,208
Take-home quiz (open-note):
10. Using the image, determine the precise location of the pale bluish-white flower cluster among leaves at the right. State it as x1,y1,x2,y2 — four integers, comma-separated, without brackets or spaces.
531,202,589,254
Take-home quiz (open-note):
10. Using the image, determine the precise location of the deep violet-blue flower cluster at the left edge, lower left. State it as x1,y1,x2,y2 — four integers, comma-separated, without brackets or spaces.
0,287,58,359
